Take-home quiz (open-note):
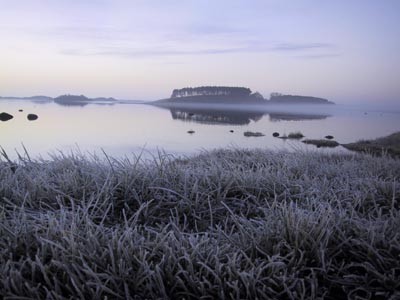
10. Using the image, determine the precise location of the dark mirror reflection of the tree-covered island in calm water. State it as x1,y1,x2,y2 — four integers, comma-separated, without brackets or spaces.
169,108,329,125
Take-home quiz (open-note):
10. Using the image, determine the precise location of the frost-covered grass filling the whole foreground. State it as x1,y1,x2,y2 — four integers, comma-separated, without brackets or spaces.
0,149,400,299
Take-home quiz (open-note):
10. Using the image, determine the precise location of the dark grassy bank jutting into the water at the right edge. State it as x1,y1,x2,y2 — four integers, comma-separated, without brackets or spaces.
342,132,400,157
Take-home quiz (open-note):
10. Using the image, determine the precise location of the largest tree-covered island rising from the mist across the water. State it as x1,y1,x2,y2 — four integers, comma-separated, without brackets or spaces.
151,86,334,106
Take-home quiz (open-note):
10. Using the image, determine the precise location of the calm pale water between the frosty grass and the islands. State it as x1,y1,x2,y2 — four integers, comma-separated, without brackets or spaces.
0,100,400,158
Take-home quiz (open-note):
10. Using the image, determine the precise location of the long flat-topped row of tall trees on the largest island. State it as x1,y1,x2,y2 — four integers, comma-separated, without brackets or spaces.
171,86,251,98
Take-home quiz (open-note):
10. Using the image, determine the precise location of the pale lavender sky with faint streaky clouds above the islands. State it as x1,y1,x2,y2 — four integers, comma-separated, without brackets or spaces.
0,0,400,103
